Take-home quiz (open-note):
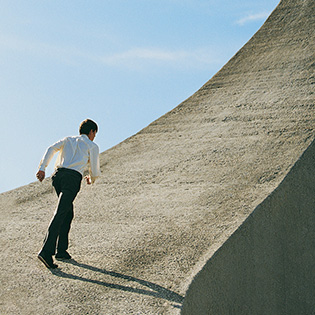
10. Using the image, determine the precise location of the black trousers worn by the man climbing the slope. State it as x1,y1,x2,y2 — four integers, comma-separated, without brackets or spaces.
42,168,82,255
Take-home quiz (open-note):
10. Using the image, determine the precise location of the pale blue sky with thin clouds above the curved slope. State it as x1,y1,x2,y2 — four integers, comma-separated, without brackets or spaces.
0,0,279,192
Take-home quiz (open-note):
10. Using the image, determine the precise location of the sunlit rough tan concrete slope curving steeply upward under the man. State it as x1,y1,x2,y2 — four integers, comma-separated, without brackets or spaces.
0,0,315,314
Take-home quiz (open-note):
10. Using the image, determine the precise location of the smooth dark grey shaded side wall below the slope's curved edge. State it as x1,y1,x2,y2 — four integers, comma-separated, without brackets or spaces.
182,142,315,315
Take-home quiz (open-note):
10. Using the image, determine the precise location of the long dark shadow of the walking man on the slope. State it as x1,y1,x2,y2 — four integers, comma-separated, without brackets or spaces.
50,259,184,308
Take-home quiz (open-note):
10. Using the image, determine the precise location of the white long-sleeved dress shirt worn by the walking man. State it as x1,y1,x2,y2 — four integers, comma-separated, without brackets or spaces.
39,135,101,183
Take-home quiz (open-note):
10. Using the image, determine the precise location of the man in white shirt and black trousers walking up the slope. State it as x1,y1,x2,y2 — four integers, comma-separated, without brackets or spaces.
36,119,100,268
